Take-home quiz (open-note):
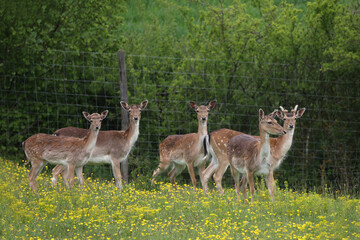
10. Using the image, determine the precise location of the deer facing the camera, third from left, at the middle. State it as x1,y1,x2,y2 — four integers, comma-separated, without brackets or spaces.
151,100,216,191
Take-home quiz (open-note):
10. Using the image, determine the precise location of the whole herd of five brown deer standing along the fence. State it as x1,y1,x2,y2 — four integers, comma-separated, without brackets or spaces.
22,100,305,202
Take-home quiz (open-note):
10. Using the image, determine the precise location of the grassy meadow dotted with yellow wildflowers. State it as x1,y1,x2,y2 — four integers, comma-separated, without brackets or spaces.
0,159,360,239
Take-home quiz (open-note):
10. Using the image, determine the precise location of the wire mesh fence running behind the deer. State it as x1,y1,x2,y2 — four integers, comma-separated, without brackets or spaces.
0,49,360,192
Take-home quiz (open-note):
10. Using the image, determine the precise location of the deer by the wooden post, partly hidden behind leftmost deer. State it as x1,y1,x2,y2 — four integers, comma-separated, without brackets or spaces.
53,100,148,189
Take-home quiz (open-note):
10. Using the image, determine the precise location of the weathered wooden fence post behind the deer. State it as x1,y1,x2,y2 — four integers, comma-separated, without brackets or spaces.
118,50,129,182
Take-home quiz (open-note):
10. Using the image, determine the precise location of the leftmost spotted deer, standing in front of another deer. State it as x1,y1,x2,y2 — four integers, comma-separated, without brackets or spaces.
22,110,108,192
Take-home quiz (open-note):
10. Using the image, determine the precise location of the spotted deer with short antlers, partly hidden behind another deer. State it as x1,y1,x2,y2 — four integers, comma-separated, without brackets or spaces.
204,105,305,196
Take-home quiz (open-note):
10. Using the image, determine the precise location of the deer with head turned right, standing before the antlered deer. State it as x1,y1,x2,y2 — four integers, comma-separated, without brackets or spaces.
227,109,286,203
